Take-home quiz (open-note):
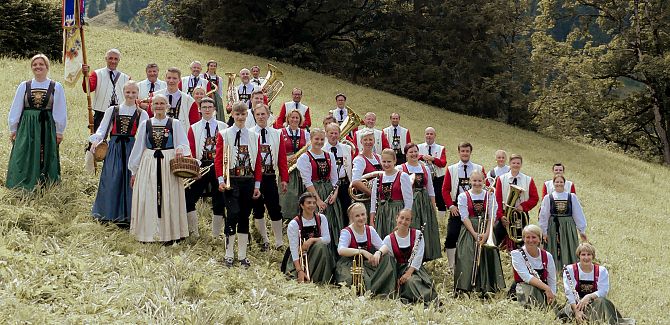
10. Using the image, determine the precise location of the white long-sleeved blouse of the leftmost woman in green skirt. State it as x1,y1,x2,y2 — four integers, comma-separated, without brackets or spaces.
8,78,67,134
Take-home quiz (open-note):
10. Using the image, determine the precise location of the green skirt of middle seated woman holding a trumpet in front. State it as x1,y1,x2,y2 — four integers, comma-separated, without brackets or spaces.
336,254,397,295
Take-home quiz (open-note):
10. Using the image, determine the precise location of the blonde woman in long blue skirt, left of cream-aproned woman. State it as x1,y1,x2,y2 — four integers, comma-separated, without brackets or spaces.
89,80,149,227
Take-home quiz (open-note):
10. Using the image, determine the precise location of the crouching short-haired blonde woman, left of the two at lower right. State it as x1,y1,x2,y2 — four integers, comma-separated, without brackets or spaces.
510,225,556,308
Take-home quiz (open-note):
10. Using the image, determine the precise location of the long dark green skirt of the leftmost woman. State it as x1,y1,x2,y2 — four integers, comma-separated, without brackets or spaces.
5,109,60,191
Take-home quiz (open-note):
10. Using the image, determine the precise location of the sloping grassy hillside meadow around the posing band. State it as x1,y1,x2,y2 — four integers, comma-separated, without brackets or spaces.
0,27,670,324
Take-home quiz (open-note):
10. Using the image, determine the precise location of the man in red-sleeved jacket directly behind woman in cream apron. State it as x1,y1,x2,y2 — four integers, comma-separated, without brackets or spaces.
153,67,200,130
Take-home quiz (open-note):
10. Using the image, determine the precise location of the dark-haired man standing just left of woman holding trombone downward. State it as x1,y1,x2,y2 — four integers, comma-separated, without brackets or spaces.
442,142,486,270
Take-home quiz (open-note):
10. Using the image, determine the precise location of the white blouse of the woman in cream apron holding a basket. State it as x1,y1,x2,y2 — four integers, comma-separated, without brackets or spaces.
128,117,191,175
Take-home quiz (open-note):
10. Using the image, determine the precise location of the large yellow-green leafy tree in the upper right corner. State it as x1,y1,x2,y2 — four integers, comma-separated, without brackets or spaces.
532,0,670,164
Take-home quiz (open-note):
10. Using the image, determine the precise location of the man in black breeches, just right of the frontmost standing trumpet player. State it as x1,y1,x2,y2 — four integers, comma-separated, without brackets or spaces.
252,102,288,252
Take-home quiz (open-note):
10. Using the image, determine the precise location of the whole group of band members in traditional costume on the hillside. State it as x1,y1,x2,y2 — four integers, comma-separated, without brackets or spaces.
6,49,636,320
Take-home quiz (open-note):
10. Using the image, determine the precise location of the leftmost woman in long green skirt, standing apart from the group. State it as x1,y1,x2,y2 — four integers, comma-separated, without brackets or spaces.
5,54,67,191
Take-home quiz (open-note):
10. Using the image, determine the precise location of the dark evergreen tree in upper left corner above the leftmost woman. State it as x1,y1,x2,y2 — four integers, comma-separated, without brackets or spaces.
0,0,63,61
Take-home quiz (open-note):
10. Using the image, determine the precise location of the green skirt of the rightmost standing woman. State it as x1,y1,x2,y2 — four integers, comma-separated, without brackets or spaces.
547,217,579,271
